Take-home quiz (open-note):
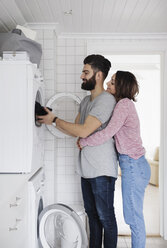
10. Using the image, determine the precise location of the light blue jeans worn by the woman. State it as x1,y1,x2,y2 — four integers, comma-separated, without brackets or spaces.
119,154,150,248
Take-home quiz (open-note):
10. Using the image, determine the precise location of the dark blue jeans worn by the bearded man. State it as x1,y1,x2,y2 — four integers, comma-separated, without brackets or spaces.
81,176,117,248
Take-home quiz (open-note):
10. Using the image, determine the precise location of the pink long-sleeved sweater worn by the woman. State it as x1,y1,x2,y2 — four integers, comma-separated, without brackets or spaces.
80,98,145,159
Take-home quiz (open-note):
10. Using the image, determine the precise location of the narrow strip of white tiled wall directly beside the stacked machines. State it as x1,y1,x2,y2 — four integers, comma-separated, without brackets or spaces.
37,30,56,205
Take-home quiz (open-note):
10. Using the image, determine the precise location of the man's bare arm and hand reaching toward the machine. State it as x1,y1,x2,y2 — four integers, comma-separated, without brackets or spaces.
38,108,102,138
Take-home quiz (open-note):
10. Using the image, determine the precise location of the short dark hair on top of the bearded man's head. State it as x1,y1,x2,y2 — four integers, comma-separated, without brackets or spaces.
83,54,111,79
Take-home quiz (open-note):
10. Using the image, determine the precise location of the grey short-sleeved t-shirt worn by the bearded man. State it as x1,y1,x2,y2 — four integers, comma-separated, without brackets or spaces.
77,91,118,178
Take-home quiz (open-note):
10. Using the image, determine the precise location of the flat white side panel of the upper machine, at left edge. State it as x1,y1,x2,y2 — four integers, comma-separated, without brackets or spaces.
0,62,28,173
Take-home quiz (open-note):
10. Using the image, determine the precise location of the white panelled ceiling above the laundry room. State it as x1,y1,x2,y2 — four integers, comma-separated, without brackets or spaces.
0,0,167,34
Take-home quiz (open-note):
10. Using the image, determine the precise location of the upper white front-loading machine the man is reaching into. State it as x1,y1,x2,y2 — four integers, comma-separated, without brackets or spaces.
0,57,44,173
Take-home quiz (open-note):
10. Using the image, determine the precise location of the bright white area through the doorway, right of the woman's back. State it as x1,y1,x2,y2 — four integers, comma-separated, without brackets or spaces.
134,70,160,159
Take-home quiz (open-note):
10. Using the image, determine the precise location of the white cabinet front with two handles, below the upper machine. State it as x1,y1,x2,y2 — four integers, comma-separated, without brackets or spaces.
0,175,28,248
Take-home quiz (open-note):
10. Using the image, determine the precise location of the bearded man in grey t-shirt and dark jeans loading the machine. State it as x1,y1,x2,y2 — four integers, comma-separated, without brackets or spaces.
38,54,117,248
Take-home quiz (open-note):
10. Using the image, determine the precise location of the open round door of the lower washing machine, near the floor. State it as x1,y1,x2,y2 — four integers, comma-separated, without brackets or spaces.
39,204,88,248
